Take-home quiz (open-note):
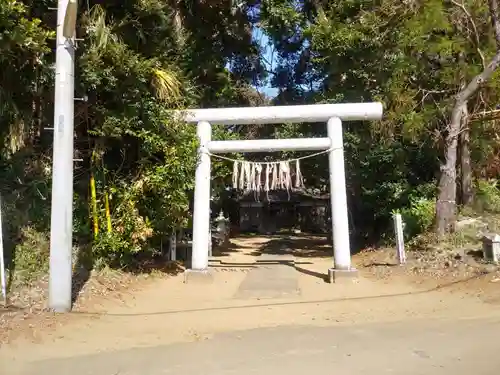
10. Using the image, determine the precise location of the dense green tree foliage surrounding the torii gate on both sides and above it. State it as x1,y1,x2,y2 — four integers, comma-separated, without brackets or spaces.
4,0,500,284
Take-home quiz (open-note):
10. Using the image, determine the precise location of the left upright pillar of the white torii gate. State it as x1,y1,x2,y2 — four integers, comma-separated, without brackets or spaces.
191,121,212,271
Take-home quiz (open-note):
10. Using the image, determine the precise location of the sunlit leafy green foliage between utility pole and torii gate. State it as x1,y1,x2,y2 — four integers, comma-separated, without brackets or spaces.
76,6,205,267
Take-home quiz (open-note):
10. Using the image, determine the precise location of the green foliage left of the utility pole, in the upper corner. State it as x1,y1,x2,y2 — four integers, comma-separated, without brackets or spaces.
0,0,54,158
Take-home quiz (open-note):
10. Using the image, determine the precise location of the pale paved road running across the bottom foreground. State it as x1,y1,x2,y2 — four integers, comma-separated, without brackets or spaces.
9,316,500,375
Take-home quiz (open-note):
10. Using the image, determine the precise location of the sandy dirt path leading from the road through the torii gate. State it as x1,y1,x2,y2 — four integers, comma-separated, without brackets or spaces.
0,237,500,371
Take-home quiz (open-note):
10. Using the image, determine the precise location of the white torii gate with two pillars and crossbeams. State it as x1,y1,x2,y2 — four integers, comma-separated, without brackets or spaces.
178,103,383,282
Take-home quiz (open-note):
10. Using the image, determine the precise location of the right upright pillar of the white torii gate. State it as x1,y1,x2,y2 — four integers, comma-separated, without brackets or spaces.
327,117,351,271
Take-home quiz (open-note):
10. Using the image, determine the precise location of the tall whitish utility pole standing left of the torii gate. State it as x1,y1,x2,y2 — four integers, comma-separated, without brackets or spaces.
49,0,74,312
